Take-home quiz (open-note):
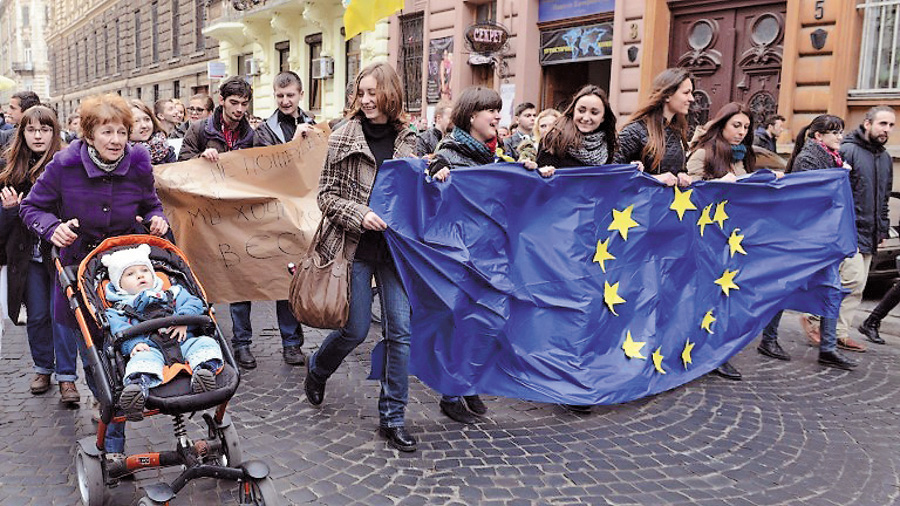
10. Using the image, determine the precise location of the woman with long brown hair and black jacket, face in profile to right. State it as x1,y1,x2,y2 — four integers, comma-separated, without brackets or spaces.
613,68,694,186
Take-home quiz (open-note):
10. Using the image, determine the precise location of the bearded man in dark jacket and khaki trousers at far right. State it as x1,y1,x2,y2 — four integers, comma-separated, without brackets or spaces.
838,106,896,344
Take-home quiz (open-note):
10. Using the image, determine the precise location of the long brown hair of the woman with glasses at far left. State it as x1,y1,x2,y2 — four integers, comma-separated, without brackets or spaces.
0,105,62,188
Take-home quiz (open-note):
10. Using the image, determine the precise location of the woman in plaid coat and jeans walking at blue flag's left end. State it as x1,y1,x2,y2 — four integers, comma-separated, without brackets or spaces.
304,62,416,452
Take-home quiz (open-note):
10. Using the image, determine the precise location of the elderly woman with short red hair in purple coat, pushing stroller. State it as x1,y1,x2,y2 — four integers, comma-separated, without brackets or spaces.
19,94,169,458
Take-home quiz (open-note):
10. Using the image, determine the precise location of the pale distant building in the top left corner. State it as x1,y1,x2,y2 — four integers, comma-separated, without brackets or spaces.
0,0,51,104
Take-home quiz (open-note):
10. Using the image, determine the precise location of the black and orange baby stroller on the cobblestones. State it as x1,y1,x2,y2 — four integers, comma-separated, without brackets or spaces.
53,235,281,506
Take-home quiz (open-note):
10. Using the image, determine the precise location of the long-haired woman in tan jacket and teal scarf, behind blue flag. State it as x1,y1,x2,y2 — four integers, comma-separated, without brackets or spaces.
687,102,756,181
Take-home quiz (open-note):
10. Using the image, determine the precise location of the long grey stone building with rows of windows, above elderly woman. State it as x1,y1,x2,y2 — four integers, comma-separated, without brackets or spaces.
46,0,219,118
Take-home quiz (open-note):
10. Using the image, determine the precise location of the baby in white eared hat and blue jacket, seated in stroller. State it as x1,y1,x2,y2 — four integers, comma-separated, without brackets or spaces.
100,244,223,421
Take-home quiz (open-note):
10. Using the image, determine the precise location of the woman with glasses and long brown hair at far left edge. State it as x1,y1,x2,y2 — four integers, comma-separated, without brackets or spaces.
0,105,81,403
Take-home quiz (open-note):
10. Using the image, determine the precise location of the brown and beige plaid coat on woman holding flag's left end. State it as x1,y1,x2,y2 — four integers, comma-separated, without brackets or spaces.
316,118,416,262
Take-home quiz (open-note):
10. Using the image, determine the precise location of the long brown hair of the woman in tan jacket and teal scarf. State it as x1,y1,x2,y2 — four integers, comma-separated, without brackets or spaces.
691,102,756,179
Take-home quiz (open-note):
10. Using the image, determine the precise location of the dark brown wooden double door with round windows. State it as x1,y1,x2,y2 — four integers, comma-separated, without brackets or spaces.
669,1,787,127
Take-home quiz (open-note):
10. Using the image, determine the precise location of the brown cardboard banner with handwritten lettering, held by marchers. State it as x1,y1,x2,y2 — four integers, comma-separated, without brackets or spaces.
153,131,328,303
